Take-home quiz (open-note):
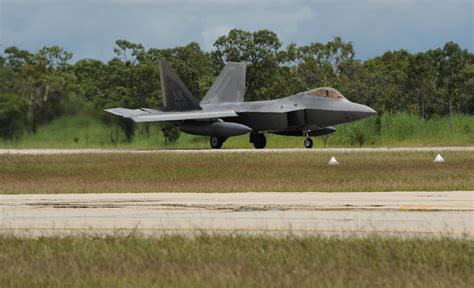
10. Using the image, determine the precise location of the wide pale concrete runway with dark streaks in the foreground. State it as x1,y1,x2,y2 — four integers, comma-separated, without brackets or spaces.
0,191,474,238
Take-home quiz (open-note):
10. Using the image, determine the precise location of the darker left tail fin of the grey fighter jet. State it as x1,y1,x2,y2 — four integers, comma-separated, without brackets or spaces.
160,60,201,111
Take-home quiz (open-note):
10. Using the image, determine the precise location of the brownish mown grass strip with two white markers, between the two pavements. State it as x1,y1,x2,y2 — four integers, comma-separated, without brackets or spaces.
0,152,474,194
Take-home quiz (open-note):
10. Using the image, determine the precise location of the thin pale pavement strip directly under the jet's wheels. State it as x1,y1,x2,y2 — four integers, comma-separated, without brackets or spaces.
0,146,474,155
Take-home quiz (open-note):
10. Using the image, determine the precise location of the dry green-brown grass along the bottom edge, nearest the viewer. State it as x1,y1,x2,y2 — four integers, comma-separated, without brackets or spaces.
0,235,474,287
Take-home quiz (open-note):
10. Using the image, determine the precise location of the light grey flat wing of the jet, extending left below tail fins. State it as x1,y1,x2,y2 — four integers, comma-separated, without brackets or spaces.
105,108,238,122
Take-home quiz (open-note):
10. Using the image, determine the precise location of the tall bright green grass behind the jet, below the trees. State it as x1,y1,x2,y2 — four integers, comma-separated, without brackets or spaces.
0,113,474,148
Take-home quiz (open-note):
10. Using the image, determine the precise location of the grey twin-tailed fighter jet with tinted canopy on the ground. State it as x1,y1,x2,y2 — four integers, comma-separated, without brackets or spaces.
105,60,375,149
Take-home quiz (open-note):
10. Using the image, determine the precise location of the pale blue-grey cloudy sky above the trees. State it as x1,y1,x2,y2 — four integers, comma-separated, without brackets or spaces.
0,0,474,61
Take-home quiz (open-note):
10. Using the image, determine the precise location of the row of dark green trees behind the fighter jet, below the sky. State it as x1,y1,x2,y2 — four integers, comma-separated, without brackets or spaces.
0,29,474,141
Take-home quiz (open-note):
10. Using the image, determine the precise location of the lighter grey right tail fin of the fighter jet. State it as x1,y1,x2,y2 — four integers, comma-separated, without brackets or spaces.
201,62,246,104
